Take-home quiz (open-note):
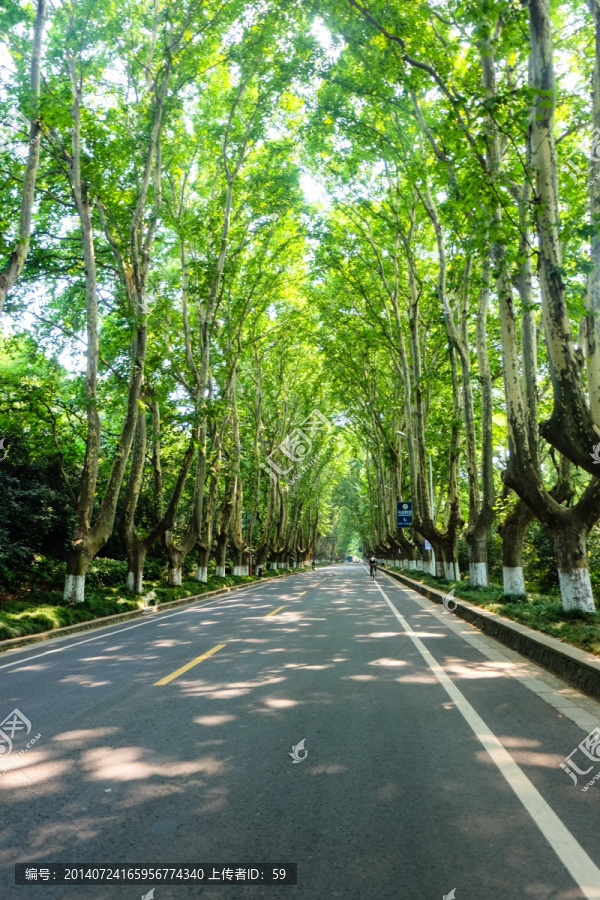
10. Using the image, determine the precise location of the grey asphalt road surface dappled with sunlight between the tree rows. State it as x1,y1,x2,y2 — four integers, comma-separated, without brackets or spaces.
0,564,600,900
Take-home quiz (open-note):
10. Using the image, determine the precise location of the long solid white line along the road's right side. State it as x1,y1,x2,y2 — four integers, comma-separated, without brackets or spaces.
377,585,600,900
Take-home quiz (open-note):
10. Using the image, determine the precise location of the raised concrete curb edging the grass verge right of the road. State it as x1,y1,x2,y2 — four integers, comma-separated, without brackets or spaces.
382,567,600,699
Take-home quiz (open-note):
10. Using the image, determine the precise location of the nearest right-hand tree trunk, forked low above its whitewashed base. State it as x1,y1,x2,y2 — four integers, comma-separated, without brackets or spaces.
474,0,600,612
